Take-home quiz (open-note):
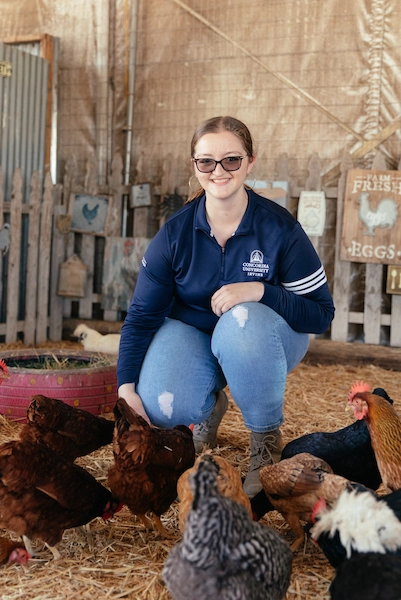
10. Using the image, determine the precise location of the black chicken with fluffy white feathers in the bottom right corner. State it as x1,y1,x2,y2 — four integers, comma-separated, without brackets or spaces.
310,485,401,600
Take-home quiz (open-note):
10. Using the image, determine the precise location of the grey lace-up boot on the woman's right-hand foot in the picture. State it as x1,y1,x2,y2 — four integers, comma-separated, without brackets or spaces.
243,429,283,498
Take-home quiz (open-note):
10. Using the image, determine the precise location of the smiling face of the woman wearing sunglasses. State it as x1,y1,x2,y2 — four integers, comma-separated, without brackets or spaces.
194,131,256,200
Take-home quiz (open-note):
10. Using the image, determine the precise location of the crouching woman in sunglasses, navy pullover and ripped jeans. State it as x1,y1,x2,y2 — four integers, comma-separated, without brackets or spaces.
117,117,334,497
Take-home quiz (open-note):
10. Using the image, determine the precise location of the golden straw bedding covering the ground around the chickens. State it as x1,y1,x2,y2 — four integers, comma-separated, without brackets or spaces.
0,344,401,600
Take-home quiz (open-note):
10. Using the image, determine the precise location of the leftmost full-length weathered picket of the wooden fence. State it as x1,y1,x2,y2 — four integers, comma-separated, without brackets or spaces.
6,169,22,343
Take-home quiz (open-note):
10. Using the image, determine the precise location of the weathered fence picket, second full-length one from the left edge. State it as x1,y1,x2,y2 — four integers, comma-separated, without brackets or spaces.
24,171,41,345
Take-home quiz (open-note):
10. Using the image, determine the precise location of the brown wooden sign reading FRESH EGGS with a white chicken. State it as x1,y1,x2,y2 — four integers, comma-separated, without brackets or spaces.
340,169,401,265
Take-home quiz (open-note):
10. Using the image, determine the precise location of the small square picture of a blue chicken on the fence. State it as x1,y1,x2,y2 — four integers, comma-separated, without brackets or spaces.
68,194,110,236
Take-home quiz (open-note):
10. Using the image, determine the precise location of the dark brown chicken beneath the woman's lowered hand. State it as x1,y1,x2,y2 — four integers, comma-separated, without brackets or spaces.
107,398,195,537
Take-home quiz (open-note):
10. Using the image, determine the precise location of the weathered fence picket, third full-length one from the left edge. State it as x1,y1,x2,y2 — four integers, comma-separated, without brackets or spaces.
36,173,54,343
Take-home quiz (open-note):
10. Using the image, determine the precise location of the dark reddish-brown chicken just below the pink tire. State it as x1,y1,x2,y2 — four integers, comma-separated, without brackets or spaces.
20,395,114,461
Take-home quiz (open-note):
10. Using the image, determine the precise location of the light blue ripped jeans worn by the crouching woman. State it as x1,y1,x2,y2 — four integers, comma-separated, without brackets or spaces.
137,302,309,432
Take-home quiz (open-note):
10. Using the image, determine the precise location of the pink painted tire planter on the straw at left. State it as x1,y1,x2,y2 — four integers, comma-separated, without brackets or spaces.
0,349,117,422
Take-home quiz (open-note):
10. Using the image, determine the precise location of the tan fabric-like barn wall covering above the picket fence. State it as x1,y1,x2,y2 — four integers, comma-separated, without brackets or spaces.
0,0,401,186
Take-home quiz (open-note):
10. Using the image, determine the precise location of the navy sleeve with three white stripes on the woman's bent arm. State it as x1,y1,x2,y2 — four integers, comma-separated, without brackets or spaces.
261,223,334,333
